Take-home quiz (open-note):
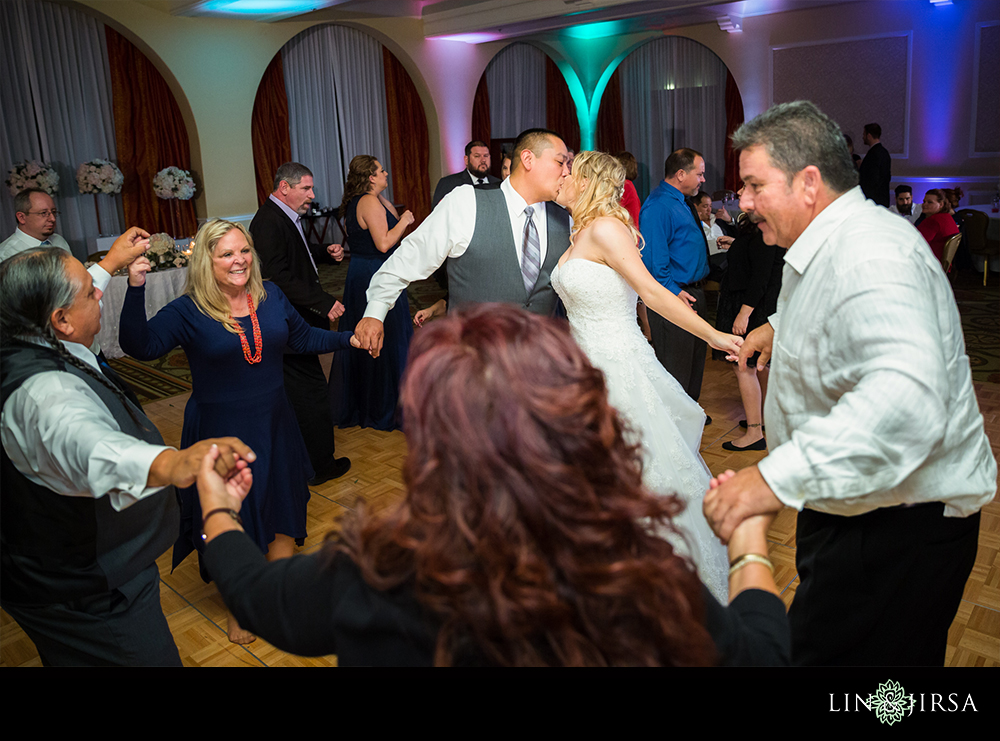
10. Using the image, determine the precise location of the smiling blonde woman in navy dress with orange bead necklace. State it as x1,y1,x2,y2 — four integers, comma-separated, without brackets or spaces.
120,220,353,643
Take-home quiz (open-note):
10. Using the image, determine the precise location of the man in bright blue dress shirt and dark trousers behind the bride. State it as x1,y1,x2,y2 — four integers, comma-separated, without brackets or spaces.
639,149,708,401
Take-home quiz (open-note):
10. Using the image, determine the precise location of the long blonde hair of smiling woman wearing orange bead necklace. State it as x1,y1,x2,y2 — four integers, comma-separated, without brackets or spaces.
184,219,267,334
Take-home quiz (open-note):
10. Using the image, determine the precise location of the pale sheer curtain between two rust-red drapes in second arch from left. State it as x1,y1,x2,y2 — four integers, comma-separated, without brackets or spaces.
282,25,392,207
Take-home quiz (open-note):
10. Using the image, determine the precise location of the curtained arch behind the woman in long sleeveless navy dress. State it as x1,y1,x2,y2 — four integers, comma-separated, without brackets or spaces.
251,24,430,219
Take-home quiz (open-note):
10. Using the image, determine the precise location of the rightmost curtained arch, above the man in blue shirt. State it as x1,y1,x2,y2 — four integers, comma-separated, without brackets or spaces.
593,36,743,198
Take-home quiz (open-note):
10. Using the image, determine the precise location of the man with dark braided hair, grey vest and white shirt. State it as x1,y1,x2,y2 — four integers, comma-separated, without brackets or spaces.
0,241,254,666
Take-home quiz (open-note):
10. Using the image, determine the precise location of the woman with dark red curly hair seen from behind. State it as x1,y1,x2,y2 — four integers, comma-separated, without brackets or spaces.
199,304,788,666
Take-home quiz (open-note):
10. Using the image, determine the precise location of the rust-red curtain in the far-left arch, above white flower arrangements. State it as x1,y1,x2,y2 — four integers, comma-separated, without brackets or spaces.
105,26,200,237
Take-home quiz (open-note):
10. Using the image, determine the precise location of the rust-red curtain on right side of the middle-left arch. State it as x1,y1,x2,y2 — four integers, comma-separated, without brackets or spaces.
382,46,431,224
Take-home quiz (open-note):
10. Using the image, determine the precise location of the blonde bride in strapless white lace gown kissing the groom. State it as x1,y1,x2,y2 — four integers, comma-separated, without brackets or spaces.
552,152,742,604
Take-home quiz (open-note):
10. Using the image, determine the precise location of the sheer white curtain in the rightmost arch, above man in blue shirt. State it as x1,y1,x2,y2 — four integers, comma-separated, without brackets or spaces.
620,36,727,199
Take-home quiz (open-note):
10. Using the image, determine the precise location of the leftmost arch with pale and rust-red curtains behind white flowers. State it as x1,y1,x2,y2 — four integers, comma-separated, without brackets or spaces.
0,0,201,249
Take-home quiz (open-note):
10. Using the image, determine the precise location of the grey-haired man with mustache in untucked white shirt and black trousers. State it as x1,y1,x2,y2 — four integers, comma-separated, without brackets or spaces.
704,101,997,666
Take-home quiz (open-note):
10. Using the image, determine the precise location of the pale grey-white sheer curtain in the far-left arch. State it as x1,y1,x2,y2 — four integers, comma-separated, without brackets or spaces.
0,0,121,258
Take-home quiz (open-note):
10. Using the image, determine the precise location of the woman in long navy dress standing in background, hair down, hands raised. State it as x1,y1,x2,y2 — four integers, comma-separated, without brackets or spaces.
330,154,413,430
